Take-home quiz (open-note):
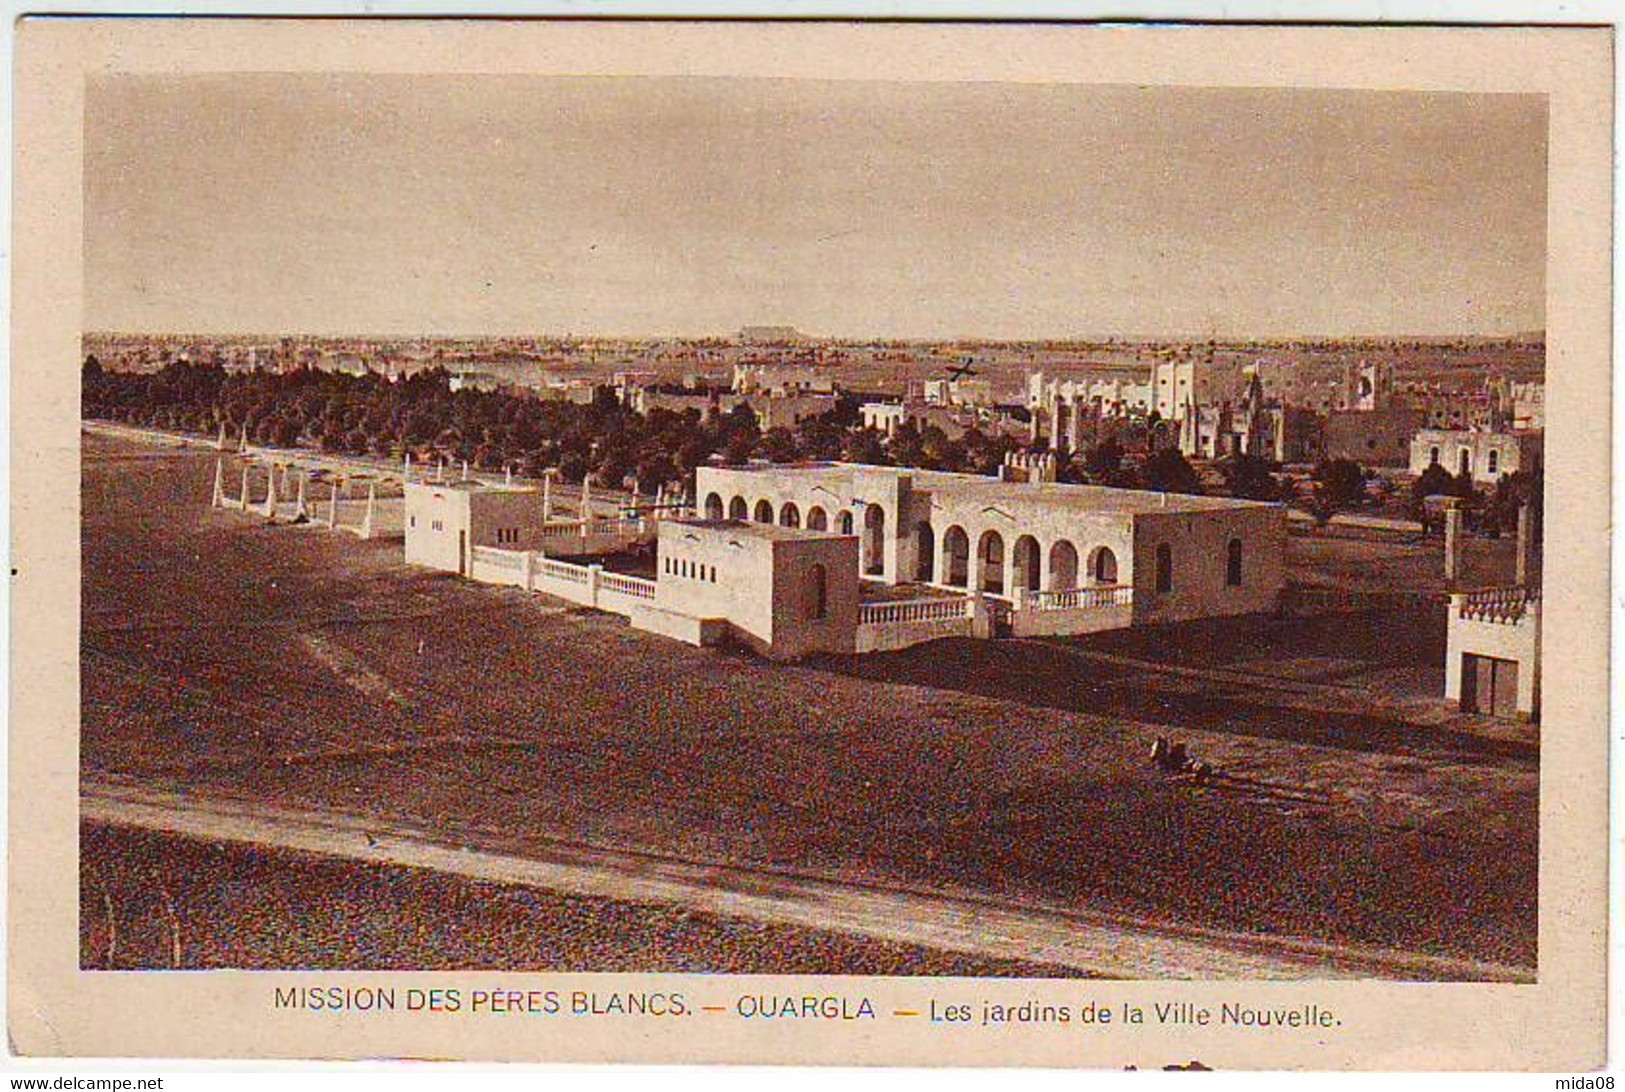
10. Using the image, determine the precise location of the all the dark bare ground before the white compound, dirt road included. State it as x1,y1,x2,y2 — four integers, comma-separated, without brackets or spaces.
81,434,1539,978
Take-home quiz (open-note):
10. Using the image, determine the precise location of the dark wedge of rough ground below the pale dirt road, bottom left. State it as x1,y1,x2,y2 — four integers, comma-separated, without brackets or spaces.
80,824,1077,978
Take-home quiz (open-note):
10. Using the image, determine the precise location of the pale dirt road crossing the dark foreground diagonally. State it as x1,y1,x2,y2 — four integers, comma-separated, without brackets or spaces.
81,783,1528,982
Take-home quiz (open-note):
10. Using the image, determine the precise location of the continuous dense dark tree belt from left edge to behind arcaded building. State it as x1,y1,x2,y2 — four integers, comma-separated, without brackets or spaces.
81,354,1016,492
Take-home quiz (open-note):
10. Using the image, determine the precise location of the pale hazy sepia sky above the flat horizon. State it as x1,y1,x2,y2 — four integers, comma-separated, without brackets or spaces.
85,75,1545,338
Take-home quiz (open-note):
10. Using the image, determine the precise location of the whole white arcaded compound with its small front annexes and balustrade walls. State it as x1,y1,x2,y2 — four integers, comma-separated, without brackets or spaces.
406,463,1285,660
